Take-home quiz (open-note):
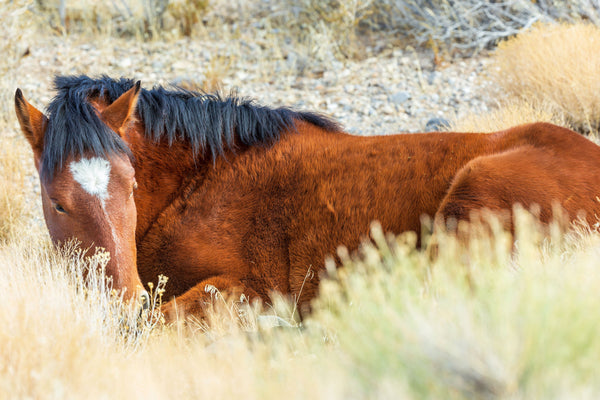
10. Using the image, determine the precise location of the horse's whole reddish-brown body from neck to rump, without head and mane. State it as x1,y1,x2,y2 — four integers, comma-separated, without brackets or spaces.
139,123,600,310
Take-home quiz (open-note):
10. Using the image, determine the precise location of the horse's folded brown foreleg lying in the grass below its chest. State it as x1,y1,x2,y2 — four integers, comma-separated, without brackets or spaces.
161,276,259,324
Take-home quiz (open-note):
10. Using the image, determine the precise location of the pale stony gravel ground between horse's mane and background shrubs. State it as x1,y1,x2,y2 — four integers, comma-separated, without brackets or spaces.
15,37,500,135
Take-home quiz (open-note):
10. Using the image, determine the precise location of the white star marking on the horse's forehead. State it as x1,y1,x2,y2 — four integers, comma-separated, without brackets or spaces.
69,157,110,200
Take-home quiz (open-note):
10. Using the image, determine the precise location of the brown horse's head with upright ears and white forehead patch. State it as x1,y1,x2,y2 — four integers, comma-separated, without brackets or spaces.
15,82,149,306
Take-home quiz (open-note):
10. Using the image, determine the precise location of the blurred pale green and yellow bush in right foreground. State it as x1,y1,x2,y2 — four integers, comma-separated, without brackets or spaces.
312,215,600,398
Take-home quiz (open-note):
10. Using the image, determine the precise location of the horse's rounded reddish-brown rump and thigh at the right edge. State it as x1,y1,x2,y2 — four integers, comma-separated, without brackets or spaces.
436,123,600,227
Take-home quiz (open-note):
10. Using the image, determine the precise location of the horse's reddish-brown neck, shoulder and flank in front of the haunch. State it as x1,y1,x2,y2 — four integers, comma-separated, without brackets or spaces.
150,124,482,299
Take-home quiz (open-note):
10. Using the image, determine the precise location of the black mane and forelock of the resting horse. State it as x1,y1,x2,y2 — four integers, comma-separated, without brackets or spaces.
40,76,340,178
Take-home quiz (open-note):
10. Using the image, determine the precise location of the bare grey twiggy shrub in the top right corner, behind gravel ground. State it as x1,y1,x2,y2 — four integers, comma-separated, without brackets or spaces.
382,0,600,54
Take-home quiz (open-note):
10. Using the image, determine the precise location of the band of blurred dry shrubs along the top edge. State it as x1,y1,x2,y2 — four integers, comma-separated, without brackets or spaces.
31,0,600,57
